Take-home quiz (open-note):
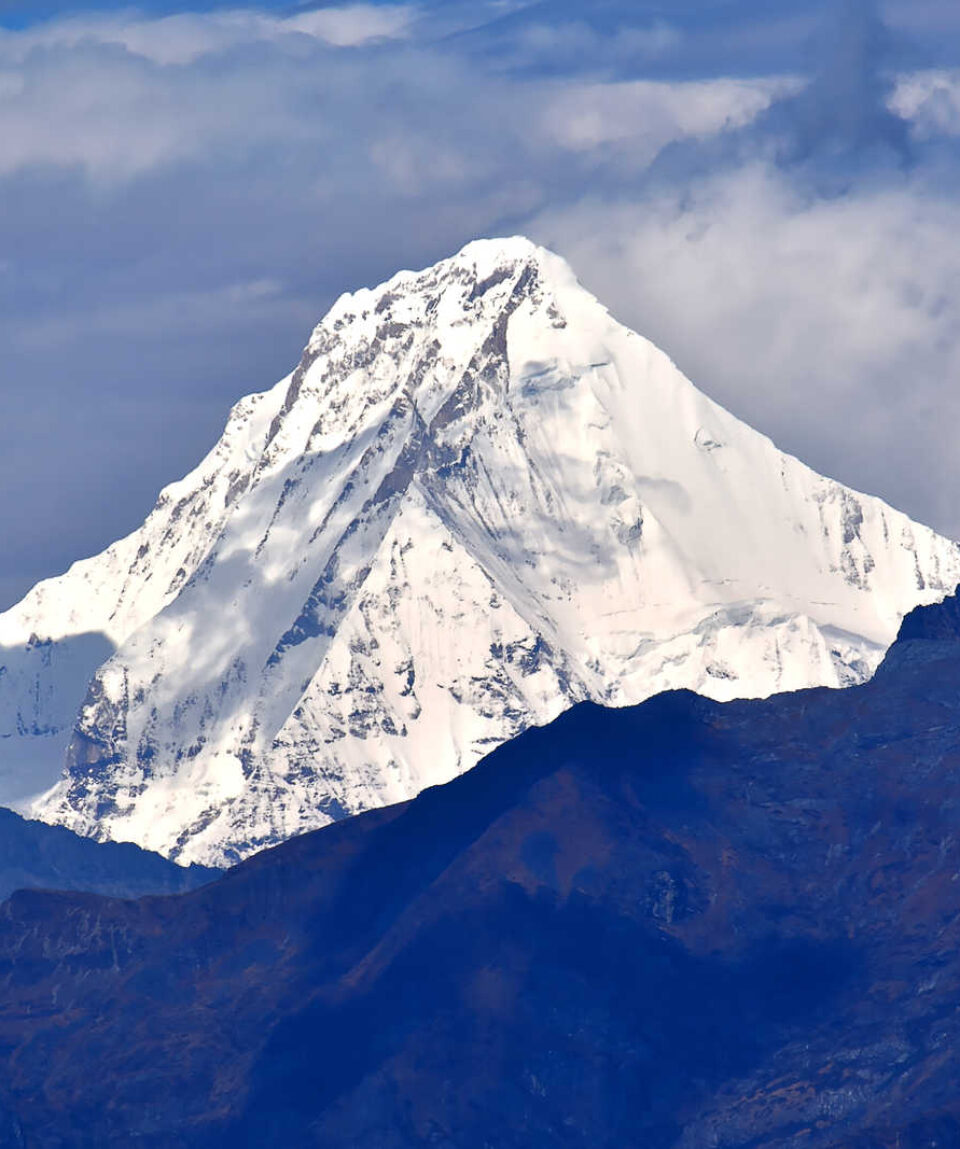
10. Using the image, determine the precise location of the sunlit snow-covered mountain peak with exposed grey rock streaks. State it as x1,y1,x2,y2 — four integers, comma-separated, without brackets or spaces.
0,239,960,863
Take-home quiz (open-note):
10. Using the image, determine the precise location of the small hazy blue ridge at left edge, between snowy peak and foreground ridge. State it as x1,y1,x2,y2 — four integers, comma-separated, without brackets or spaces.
0,808,220,901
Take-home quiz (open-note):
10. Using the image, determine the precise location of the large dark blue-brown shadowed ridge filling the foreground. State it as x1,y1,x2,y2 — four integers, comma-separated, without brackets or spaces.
0,600,960,1149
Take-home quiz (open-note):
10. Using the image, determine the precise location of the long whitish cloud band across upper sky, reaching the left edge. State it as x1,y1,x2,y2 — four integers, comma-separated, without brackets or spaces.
0,5,779,183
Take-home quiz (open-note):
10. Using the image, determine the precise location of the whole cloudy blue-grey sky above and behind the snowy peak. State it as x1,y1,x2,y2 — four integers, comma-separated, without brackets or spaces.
0,0,960,604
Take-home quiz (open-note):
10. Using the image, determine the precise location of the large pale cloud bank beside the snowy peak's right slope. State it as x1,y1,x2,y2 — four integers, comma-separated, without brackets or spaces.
535,163,960,537
